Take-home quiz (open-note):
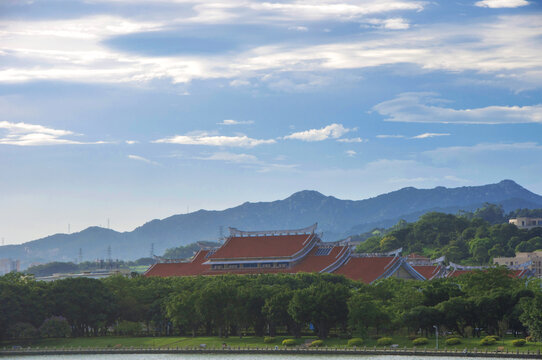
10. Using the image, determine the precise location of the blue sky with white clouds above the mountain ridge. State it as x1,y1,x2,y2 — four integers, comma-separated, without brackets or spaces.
0,0,542,245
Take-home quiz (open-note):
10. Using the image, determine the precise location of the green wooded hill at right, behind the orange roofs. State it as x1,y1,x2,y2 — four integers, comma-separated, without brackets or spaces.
356,204,542,265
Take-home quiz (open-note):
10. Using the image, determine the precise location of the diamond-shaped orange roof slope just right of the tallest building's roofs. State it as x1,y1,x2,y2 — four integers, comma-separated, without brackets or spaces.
334,256,399,284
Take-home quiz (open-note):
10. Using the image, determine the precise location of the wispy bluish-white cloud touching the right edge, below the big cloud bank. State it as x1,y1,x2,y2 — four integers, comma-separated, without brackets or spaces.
374,93,542,124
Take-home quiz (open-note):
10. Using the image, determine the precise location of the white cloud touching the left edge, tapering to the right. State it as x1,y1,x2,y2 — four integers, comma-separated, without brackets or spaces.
0,121,104,146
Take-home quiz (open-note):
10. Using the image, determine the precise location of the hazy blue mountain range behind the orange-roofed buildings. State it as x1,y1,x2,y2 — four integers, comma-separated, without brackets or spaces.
0,180,542,265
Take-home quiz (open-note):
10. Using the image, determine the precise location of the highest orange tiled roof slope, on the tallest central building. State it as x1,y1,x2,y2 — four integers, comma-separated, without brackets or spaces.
209,234,315,260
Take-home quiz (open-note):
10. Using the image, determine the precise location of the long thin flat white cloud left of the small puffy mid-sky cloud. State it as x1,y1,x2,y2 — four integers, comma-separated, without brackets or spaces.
153,132,276,147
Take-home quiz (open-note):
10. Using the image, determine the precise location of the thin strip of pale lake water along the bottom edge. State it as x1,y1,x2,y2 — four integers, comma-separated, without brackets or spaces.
0,354,528,360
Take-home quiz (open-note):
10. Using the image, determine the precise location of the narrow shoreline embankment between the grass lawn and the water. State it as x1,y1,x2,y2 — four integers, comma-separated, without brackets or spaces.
0,347,541,359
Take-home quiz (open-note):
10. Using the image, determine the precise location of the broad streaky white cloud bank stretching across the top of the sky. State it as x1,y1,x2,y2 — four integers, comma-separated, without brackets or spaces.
0,10,542,90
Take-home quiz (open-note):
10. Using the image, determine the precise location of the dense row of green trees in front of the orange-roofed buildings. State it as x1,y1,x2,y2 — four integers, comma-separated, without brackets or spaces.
0,268,542,339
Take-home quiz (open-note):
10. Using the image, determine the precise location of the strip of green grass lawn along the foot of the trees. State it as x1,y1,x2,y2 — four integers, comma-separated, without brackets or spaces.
0,336,542,352
